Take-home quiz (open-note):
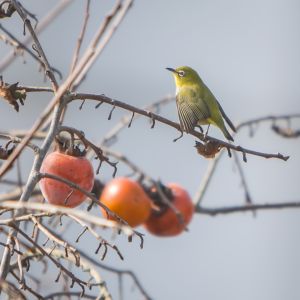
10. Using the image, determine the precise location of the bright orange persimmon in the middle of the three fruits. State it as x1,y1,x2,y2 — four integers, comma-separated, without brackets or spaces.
100,177,151,227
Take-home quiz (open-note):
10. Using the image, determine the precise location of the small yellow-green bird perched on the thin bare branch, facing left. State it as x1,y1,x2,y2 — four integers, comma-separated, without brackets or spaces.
166,66,236,142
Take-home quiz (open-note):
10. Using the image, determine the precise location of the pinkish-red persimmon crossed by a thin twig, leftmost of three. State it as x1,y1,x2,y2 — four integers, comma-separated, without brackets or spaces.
39,151,94,207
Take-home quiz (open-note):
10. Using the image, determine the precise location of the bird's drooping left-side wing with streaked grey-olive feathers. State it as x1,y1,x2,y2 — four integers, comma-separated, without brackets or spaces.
176,88,210,132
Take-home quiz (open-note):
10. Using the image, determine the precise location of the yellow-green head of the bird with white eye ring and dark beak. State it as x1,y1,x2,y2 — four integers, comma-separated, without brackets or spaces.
166,66,201,88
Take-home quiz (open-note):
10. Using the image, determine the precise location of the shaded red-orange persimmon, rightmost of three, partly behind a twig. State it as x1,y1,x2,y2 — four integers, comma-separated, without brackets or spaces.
144,183,194,237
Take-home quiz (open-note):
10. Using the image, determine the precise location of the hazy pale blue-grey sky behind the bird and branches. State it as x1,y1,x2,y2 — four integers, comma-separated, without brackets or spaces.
0,0,300,300
